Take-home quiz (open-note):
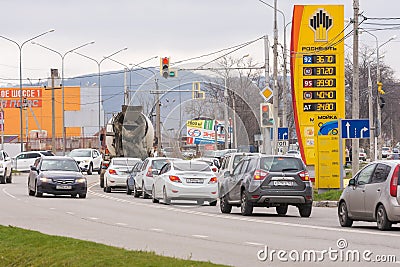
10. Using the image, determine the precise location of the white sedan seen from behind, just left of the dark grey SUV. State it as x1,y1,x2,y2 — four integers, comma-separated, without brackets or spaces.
152,160,218,206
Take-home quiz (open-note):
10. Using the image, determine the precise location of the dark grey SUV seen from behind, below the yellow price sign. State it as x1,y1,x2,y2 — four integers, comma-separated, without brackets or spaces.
219,155,313,217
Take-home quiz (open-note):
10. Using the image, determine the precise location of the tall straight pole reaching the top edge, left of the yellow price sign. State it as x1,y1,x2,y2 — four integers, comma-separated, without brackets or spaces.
272,0,279,154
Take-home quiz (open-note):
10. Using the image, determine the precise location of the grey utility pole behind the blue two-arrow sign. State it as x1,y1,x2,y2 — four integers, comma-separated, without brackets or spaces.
351,0,360,175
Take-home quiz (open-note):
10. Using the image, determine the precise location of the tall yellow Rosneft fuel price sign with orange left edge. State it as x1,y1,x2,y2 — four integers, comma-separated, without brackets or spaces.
290,5,345,165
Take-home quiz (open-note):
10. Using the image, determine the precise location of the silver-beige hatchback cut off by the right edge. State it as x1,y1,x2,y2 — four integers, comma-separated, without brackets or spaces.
338,160,400,230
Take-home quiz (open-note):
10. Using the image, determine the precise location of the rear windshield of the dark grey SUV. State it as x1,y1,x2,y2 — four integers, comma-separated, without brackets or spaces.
260,157,304,172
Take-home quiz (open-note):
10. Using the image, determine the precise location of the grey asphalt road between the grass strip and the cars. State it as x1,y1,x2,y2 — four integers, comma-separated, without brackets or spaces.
0,174,400,266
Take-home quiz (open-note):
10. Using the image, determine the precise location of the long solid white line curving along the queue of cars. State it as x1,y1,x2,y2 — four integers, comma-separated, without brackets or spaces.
88,183,400,237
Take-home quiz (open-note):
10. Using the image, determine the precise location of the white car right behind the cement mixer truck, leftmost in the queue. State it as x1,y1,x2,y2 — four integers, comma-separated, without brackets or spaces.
104,157,140,193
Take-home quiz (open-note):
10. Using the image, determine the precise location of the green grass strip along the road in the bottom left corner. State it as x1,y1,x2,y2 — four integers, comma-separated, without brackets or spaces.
0,225,227,267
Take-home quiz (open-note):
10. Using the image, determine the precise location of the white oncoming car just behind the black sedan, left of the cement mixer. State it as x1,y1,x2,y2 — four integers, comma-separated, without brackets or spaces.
68,148,103,175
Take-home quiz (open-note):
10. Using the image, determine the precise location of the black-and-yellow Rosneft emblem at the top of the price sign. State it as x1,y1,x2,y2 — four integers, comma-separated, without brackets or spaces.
309,8,333,42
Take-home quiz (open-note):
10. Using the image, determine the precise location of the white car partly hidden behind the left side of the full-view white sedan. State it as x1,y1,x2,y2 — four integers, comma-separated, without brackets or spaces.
133,157,174,198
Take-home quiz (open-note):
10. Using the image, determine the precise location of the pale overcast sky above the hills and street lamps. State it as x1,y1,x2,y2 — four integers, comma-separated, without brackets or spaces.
0,0,400,85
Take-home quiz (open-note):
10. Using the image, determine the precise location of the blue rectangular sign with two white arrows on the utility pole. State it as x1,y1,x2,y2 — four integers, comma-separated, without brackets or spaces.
340,119,370,139
